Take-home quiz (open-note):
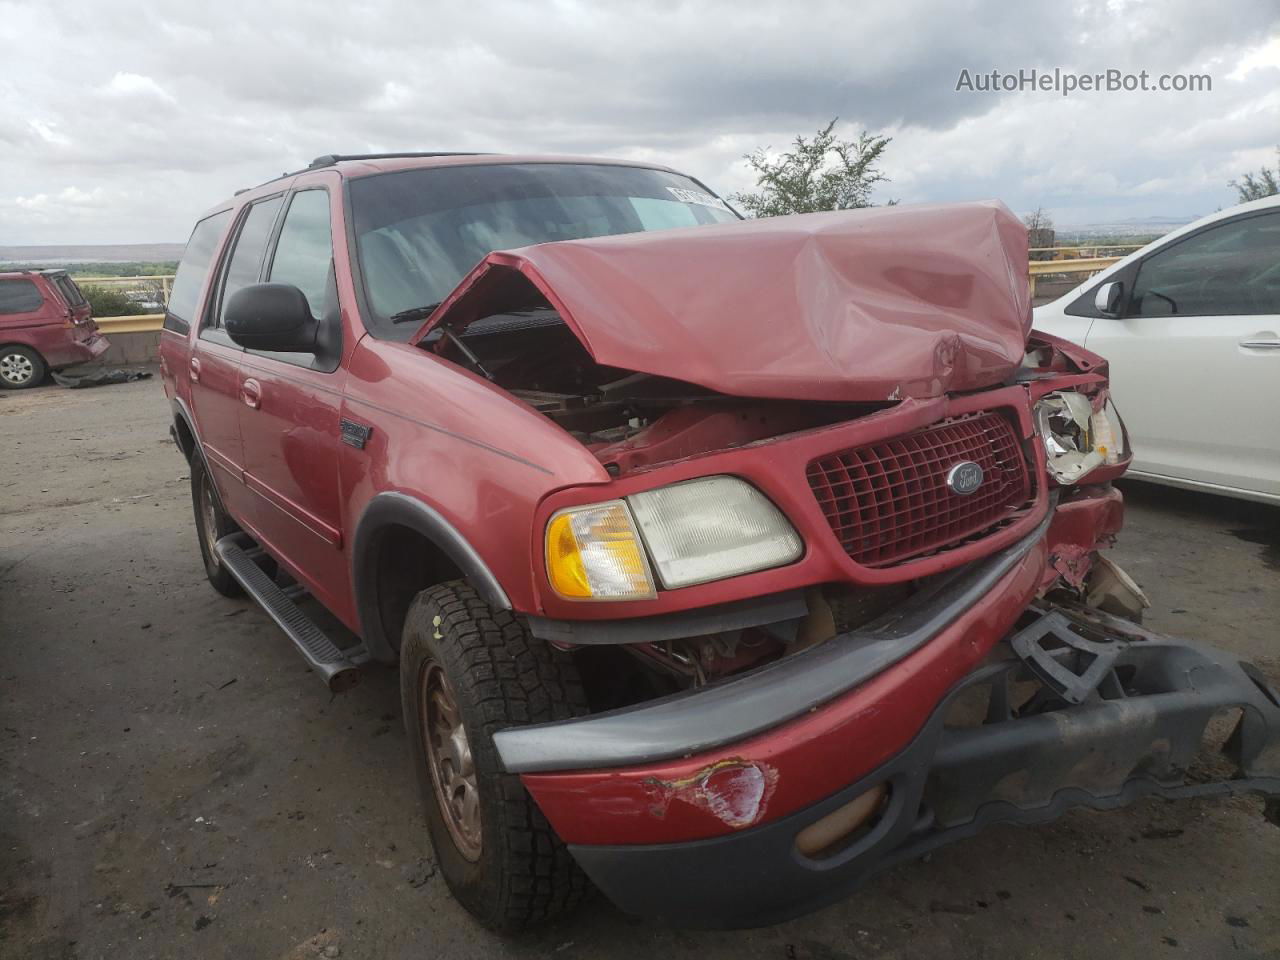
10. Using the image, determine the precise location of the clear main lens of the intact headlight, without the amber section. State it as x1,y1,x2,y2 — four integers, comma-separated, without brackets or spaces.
627,476,804,589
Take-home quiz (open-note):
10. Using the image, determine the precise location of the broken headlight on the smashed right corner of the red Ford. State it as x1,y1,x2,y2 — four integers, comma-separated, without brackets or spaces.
1036,390,1128,484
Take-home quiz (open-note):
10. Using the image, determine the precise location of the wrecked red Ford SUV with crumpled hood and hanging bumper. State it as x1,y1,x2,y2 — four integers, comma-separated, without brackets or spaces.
161,155,1280,929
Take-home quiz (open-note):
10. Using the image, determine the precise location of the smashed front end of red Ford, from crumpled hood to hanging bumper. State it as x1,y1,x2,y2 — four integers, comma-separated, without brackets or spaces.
417,205,1280,925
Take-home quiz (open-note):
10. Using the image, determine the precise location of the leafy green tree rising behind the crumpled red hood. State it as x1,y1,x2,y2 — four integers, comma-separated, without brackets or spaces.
730,118,893,216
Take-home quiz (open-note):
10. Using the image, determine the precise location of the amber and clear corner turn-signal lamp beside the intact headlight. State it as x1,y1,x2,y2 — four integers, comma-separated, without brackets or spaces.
547,500,654,600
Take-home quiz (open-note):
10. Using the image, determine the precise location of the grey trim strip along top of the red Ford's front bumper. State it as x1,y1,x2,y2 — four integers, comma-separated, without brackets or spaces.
494,504,1053,773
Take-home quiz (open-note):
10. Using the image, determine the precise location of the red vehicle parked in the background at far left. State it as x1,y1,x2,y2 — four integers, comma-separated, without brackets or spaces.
0,270,111,390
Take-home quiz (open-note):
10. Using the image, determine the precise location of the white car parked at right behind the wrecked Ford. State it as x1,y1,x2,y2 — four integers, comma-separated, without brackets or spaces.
1034,196,1280,504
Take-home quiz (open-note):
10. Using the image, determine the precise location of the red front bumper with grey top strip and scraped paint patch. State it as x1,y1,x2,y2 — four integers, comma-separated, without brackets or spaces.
504,504,1054,845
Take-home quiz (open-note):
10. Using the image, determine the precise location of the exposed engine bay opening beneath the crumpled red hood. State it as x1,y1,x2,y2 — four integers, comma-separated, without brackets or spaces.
426,301,893,476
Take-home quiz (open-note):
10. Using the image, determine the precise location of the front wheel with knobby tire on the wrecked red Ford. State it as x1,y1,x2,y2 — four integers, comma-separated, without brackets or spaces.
401,580,588,932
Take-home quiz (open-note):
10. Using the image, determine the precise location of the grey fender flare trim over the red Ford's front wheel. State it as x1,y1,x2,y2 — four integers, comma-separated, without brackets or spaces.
351,490,511,663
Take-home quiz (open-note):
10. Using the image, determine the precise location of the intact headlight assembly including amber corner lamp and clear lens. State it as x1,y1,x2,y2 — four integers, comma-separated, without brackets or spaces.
547,476,804,600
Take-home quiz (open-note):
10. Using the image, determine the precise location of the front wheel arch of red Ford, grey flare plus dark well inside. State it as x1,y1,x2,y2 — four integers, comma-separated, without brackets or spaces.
351,492,511,663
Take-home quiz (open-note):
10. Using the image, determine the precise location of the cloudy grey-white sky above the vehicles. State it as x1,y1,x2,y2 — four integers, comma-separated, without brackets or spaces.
0,0,1280,244
